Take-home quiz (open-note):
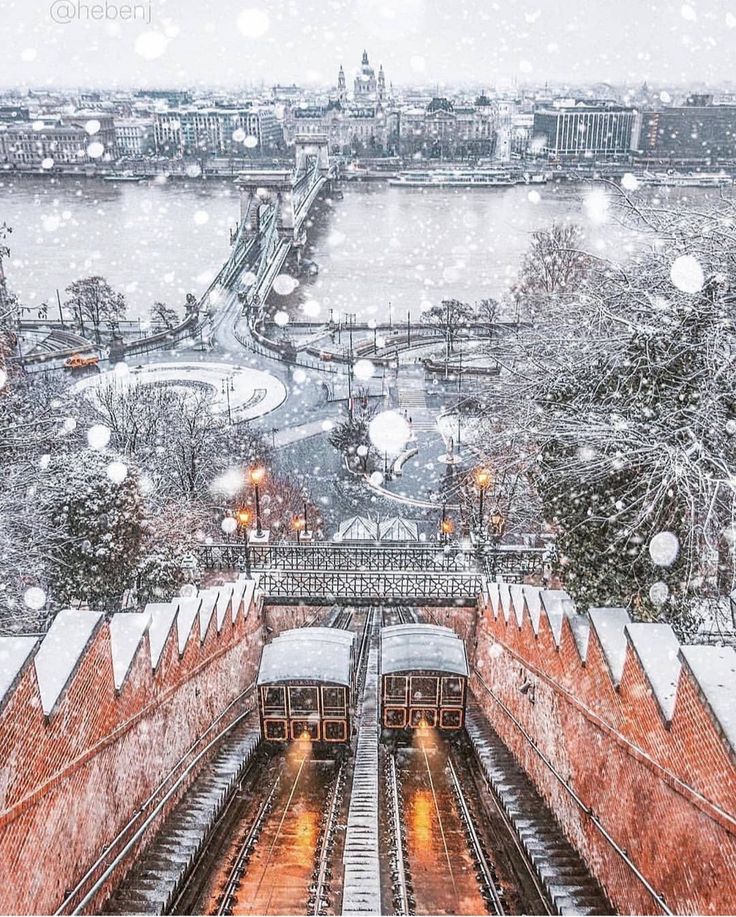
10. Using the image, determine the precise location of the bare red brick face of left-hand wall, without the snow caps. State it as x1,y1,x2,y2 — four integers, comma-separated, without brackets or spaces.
0,599,262,914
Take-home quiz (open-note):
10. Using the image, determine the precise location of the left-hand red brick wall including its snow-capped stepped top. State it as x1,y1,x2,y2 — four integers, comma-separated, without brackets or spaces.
0,581,262,914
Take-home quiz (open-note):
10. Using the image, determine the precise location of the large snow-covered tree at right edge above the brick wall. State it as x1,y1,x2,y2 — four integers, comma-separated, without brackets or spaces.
487,195,736,636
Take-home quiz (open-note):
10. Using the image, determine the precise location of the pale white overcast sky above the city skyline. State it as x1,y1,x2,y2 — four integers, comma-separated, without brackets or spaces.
0,0,736,88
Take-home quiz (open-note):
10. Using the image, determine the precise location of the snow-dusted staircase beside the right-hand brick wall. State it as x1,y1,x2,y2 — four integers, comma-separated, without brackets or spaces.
466,704,615,915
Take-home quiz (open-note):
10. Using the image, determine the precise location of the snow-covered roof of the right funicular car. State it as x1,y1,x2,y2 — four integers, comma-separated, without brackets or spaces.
381,624,469,678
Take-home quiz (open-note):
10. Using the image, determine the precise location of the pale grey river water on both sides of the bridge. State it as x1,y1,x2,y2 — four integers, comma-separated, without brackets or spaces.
0,178,724,320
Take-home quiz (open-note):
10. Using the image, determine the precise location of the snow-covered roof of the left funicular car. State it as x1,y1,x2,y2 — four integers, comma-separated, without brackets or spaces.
257,627,353,685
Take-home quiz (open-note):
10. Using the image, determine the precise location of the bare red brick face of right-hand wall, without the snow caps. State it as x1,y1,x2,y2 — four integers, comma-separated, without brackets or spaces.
426,606,736,914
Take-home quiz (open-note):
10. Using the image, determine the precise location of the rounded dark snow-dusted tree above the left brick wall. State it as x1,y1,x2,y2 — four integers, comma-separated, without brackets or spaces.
38,449,144,609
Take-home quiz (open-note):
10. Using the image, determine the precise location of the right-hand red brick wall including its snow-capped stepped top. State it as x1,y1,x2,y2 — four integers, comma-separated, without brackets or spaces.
426,583,736,914
